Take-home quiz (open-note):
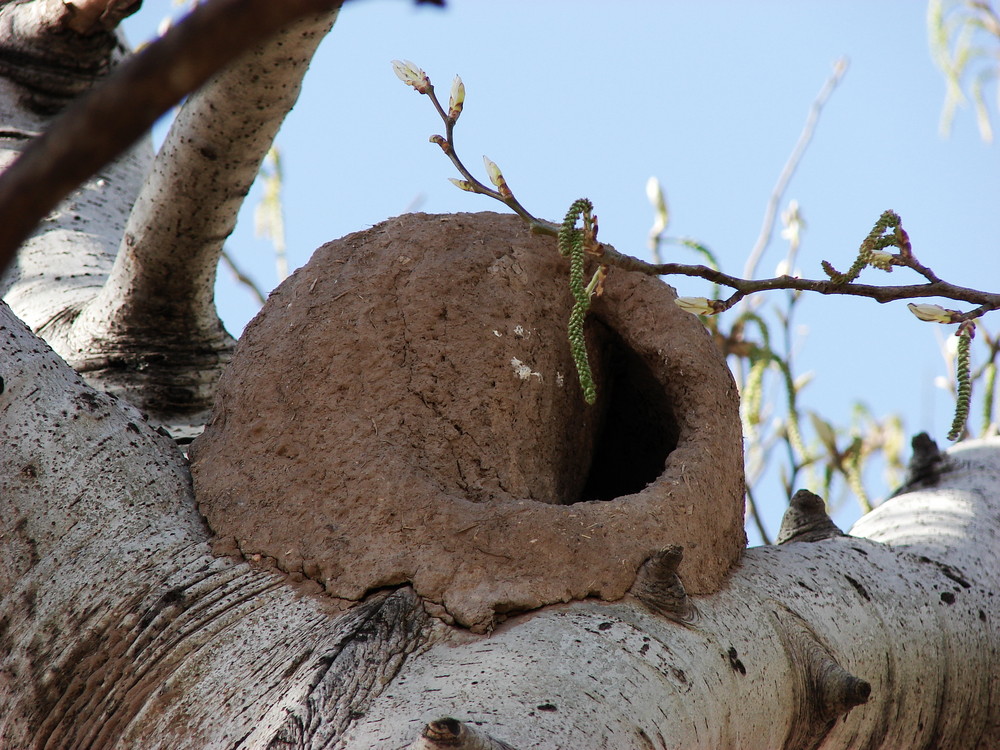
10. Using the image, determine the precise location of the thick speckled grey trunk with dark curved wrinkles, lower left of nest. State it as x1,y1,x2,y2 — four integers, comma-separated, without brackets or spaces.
0,303,443,750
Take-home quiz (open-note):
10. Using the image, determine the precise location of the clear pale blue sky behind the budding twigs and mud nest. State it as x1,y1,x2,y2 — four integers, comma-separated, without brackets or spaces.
126,0,1000,540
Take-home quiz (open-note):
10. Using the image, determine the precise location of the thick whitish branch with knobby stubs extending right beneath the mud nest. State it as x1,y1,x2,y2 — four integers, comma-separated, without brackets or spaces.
344,441,1000,750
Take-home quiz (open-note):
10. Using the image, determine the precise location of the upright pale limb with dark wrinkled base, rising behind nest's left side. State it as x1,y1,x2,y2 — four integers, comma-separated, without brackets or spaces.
46,11,336,430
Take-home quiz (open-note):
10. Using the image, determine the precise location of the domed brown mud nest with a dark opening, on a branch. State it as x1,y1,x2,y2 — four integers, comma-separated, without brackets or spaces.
192,213,744,630
